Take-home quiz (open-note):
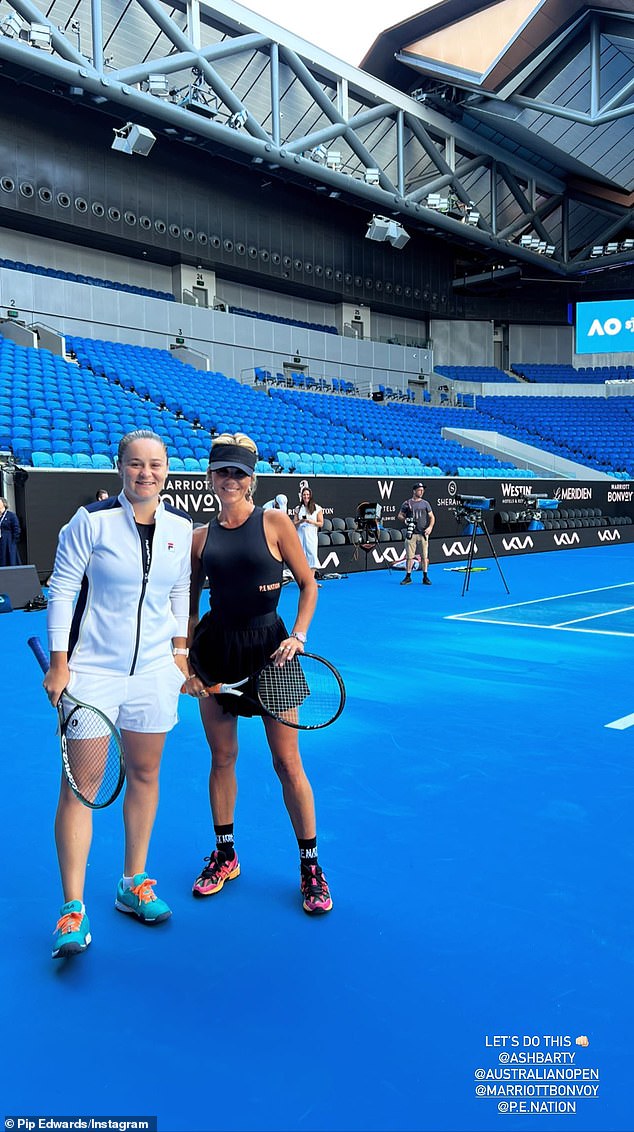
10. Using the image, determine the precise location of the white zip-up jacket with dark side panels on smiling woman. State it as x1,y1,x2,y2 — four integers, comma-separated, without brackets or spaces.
48,492,192,676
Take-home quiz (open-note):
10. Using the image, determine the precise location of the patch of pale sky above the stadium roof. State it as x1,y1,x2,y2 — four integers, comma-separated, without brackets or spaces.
237,0,425,67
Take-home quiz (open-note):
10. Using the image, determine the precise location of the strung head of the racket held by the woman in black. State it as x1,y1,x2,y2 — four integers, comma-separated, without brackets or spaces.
258,654,342,728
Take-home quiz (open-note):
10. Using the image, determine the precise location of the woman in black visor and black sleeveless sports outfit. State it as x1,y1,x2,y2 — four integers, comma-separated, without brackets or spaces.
182,432,333,915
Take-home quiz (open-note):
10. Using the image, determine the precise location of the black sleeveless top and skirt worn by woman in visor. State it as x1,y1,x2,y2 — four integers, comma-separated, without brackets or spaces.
189,507,289,717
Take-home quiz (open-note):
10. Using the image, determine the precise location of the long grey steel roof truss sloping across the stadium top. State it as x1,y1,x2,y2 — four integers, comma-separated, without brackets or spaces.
0,0,634,277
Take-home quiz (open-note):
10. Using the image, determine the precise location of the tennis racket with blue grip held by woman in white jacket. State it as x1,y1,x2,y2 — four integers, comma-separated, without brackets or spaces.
28,637,126,809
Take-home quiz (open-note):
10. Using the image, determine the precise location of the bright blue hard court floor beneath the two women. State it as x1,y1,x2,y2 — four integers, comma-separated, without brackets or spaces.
0,546,634,1132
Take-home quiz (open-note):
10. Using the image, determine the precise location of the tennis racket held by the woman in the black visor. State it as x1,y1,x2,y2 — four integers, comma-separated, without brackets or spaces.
189,652,345,731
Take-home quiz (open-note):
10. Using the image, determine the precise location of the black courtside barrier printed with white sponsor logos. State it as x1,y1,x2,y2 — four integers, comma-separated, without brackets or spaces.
6,469,634,580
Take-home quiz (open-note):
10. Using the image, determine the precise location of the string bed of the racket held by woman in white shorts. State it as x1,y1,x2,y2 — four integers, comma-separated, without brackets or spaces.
61,706,122,807
